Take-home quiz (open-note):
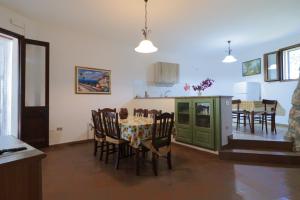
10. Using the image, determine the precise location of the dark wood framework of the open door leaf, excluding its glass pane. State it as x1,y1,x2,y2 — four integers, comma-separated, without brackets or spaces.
20,39,50,148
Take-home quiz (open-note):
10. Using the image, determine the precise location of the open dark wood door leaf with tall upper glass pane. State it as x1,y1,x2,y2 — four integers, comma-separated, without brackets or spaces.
21,39,50,148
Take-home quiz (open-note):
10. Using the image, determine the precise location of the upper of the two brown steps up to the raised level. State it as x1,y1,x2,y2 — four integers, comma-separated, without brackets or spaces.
227,137,293,152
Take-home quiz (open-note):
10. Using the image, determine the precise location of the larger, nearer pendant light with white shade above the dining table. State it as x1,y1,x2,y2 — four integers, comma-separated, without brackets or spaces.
134,0,158,53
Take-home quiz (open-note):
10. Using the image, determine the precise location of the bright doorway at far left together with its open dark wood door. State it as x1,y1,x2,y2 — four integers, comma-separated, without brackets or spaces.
0,28,49,148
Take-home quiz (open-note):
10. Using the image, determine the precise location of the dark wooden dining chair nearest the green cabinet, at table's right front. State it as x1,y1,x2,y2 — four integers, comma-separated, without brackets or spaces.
142,113,174,176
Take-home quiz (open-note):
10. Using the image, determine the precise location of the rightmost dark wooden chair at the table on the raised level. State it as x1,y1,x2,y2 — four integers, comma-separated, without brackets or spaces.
261,99,277,133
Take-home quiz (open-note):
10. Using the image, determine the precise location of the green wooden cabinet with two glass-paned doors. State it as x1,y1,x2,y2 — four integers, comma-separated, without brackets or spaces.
175,97,232,150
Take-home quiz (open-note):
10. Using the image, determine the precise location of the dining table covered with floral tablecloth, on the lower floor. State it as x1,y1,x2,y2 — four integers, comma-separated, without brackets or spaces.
120,116,153,175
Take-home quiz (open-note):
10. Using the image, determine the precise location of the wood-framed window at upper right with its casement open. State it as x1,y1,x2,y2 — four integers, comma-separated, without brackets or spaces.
264,44,300,82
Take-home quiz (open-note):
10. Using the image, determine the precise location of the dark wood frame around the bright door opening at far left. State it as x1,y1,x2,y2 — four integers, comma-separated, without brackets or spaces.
0,27,25,138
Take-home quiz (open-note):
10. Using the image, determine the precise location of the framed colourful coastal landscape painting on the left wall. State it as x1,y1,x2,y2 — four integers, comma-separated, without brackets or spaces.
75,66,111,94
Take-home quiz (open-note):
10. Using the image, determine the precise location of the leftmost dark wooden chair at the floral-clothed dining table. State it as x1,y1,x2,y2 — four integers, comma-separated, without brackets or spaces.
92,110,106,160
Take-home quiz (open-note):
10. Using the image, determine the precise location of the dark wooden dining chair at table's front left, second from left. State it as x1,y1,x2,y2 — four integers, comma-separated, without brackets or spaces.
102,111,128,169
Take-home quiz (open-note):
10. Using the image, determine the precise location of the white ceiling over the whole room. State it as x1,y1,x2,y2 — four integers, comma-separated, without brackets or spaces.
0,0,300,54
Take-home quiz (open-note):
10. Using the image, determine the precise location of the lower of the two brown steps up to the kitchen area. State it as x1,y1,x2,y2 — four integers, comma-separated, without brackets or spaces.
219,149,300,165
